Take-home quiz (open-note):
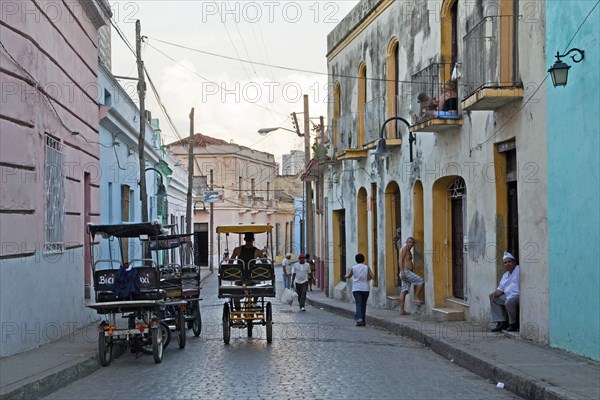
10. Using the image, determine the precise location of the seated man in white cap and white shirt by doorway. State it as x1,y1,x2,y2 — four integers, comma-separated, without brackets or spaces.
490,251,519,332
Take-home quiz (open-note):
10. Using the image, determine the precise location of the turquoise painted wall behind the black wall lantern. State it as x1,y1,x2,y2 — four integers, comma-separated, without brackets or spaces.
546,0,600,360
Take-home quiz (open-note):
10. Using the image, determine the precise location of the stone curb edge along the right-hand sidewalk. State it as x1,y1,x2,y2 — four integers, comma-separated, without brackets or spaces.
306,298,579,400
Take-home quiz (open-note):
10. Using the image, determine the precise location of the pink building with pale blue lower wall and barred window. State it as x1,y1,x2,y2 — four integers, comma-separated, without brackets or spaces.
0,0,110,357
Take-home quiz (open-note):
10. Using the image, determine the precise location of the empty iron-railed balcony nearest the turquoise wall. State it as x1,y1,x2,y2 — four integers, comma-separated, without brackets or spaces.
461,15,523,110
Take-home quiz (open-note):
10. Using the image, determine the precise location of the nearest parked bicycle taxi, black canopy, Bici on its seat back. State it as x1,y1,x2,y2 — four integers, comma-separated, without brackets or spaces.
87,222,187,366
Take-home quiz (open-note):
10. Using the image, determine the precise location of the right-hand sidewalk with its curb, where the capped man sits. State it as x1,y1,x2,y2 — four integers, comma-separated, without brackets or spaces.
307,289,600,399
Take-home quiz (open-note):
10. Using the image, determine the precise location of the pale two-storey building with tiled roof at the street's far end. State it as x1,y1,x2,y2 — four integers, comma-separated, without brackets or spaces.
167,133,295,266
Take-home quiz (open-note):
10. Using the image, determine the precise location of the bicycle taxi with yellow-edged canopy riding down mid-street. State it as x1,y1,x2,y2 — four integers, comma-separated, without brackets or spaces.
217,225,275,344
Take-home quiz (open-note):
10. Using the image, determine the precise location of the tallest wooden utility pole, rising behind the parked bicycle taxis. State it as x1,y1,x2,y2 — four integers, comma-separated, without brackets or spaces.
135,19,148,222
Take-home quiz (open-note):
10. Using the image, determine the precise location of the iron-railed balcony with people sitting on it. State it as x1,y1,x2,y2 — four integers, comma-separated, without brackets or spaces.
410,63,462,132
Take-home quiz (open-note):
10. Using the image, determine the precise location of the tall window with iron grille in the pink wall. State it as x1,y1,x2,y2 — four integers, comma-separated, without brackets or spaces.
44,134,65,253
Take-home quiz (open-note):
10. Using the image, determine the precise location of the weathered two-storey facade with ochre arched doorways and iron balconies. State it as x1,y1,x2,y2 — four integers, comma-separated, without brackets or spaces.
326,0,548,343
